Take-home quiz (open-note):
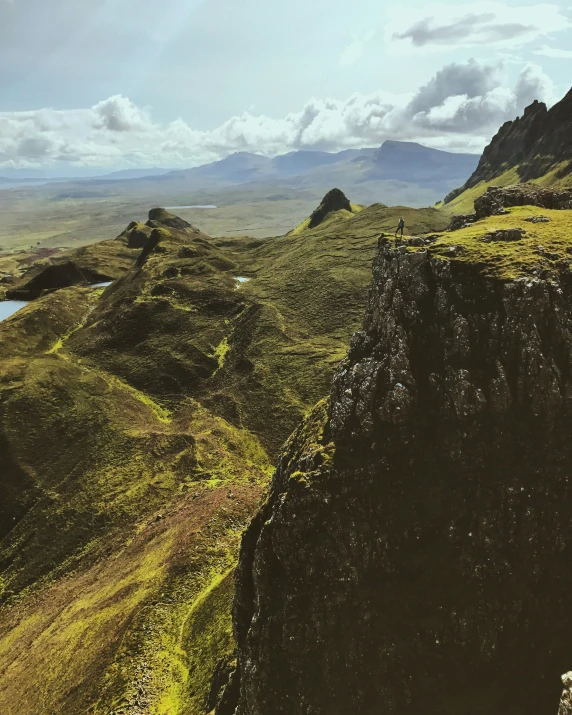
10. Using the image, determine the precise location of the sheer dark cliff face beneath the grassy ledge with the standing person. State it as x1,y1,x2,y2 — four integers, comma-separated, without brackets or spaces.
225,243,572,715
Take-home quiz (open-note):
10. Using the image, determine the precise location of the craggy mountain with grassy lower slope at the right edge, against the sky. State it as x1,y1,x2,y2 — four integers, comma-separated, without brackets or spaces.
445,89,572,213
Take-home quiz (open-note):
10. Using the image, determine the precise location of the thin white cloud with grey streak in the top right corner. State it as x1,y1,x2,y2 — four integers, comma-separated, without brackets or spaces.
390,2,572,48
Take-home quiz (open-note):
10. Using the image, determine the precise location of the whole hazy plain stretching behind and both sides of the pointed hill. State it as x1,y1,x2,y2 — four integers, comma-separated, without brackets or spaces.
0,169,452,255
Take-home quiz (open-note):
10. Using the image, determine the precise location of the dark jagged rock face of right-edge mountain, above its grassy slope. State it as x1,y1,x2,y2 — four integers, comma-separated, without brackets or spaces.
445,89,572,202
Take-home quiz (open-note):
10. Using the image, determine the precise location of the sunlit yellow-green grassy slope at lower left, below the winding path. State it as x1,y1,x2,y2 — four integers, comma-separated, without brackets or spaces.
0,278,269,715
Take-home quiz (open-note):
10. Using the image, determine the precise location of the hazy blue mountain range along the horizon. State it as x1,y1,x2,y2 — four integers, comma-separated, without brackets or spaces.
0,141,479,206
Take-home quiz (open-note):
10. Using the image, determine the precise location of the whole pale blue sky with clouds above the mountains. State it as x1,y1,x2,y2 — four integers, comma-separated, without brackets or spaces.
0,0,572,176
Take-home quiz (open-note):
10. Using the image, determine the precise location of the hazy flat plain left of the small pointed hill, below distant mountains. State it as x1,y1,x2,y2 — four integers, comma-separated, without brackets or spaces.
0,183,323,254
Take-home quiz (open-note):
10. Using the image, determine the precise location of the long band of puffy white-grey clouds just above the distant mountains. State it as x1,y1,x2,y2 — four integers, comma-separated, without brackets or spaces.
0,60,553,169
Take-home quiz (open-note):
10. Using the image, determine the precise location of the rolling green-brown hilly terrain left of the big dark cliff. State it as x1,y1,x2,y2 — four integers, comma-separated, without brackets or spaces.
0,193,448,715
